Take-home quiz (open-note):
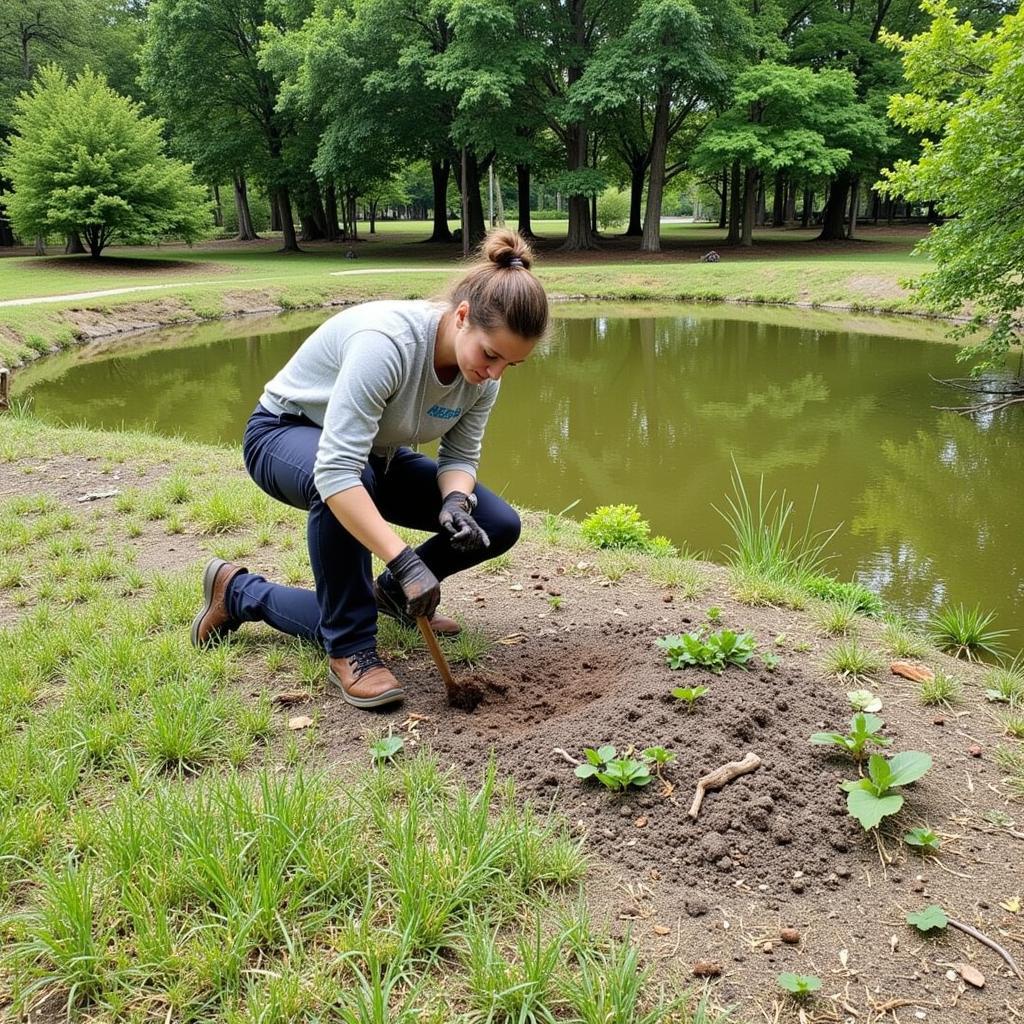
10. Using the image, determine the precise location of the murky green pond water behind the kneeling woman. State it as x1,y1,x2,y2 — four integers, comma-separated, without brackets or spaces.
14,305,1024,647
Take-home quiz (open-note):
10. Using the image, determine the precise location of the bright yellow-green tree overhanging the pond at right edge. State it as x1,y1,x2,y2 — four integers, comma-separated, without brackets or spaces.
879,0,1024,378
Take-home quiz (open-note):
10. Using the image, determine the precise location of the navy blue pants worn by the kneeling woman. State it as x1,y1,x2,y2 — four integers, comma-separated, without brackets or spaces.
227,406,520,657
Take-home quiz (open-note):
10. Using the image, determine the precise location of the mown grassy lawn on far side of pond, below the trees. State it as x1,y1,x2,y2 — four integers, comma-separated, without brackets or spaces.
0,221,927,365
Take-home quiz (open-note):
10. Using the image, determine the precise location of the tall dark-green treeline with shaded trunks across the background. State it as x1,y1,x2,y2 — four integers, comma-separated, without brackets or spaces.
0,0,1012,252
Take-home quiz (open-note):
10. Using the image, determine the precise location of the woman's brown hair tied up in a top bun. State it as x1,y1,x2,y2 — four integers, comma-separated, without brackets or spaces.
447,227,548,341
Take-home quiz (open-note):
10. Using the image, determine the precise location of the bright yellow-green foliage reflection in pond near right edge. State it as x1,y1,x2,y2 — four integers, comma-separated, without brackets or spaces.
853,415,1024,625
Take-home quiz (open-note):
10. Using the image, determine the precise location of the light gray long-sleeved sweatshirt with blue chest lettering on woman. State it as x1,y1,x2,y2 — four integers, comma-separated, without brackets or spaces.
260,301,499,501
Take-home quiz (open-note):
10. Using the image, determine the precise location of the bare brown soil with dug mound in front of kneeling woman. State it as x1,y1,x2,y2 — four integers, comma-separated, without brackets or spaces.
0,459,1024,1024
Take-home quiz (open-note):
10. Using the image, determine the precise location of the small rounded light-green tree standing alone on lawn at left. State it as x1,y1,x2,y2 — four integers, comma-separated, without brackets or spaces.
0,65,210,258
